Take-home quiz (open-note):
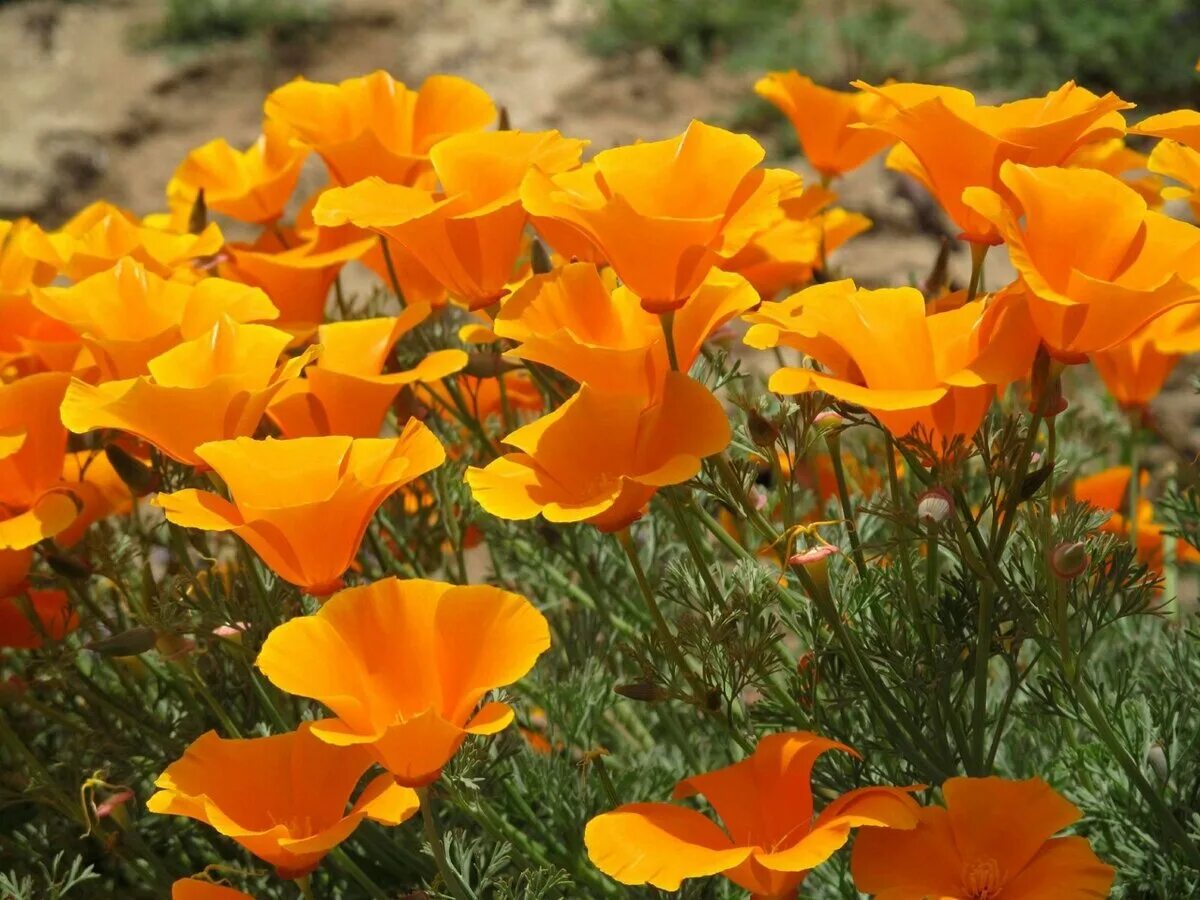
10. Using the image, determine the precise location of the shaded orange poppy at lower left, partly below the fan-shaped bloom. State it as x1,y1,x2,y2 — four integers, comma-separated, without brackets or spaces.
146,722,419,878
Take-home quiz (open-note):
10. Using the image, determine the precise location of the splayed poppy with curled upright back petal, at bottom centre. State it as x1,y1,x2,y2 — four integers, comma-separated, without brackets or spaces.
583,731,920,900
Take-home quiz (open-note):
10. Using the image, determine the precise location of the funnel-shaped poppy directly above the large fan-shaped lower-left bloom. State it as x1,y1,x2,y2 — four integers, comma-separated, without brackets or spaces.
155,420,445,595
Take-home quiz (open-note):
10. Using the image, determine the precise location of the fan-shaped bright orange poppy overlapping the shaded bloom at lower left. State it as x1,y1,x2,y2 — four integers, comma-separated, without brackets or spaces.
258,578,550,787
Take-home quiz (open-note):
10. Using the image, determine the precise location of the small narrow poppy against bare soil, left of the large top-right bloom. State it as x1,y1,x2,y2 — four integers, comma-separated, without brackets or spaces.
754,70,895,179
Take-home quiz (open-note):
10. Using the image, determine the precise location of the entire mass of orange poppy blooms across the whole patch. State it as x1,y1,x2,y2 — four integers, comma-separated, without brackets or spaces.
7,65,1200,900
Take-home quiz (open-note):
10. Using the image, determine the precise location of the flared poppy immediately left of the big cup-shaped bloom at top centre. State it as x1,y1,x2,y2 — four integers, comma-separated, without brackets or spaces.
313,131,586,310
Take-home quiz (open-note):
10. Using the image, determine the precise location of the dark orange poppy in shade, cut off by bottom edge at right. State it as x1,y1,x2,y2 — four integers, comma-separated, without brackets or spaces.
851,778,1114,900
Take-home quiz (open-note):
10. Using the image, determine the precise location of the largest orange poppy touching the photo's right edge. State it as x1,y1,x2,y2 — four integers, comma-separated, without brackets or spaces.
964,163,1200,359
